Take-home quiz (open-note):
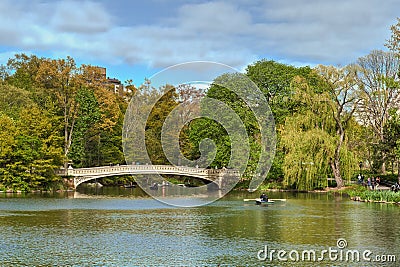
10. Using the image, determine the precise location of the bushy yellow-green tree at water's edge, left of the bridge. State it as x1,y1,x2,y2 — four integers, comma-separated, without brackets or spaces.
2,105,62,190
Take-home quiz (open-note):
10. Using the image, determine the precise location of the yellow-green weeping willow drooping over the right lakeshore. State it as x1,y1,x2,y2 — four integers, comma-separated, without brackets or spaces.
280,77,357,190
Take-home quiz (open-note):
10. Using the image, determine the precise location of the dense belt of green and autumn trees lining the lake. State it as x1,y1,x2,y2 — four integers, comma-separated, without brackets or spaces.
0,20,400,190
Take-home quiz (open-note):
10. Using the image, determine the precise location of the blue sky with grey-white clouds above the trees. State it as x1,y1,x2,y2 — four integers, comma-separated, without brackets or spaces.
0,0,400,84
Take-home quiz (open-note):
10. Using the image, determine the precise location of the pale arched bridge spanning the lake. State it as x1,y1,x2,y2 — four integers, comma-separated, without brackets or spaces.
58,165,239,189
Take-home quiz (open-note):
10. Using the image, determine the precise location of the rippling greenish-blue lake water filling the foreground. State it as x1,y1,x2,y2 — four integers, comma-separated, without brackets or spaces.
0,188,400,266
